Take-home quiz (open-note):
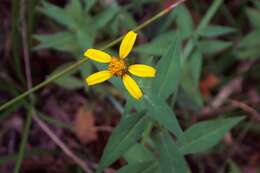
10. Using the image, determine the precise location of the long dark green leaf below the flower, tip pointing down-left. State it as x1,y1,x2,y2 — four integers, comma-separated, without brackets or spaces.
97,112,149,173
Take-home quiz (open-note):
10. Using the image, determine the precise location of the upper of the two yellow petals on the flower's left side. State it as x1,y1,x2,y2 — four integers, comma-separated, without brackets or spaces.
84,49,112,63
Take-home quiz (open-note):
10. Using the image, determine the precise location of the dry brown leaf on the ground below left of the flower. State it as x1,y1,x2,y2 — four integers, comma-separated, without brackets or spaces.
74,106,98,144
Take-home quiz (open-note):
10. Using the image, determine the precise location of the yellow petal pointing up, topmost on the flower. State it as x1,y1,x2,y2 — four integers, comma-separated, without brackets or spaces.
119,31,137,59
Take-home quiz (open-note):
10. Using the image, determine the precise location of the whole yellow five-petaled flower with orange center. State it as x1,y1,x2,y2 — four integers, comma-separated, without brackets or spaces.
84,31,156,100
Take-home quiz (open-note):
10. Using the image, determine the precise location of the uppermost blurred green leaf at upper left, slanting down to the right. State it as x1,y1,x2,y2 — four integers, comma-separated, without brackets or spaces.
40,1,77,29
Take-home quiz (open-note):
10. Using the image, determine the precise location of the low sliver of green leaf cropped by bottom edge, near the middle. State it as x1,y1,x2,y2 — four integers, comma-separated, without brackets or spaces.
117,161,160,173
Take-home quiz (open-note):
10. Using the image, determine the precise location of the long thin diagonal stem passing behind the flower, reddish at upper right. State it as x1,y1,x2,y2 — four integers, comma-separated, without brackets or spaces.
0,0,185,111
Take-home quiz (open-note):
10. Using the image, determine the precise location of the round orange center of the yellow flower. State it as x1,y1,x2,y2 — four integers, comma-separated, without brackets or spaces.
108,57,126,76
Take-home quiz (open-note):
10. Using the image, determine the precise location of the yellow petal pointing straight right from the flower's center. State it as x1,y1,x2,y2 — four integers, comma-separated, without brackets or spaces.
128,64,156,77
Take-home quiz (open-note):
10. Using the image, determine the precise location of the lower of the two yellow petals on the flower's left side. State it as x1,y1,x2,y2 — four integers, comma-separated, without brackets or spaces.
86,70,112,85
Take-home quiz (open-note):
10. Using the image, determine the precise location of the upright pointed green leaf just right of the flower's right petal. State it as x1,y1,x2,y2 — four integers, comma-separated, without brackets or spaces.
152,37,181,99
